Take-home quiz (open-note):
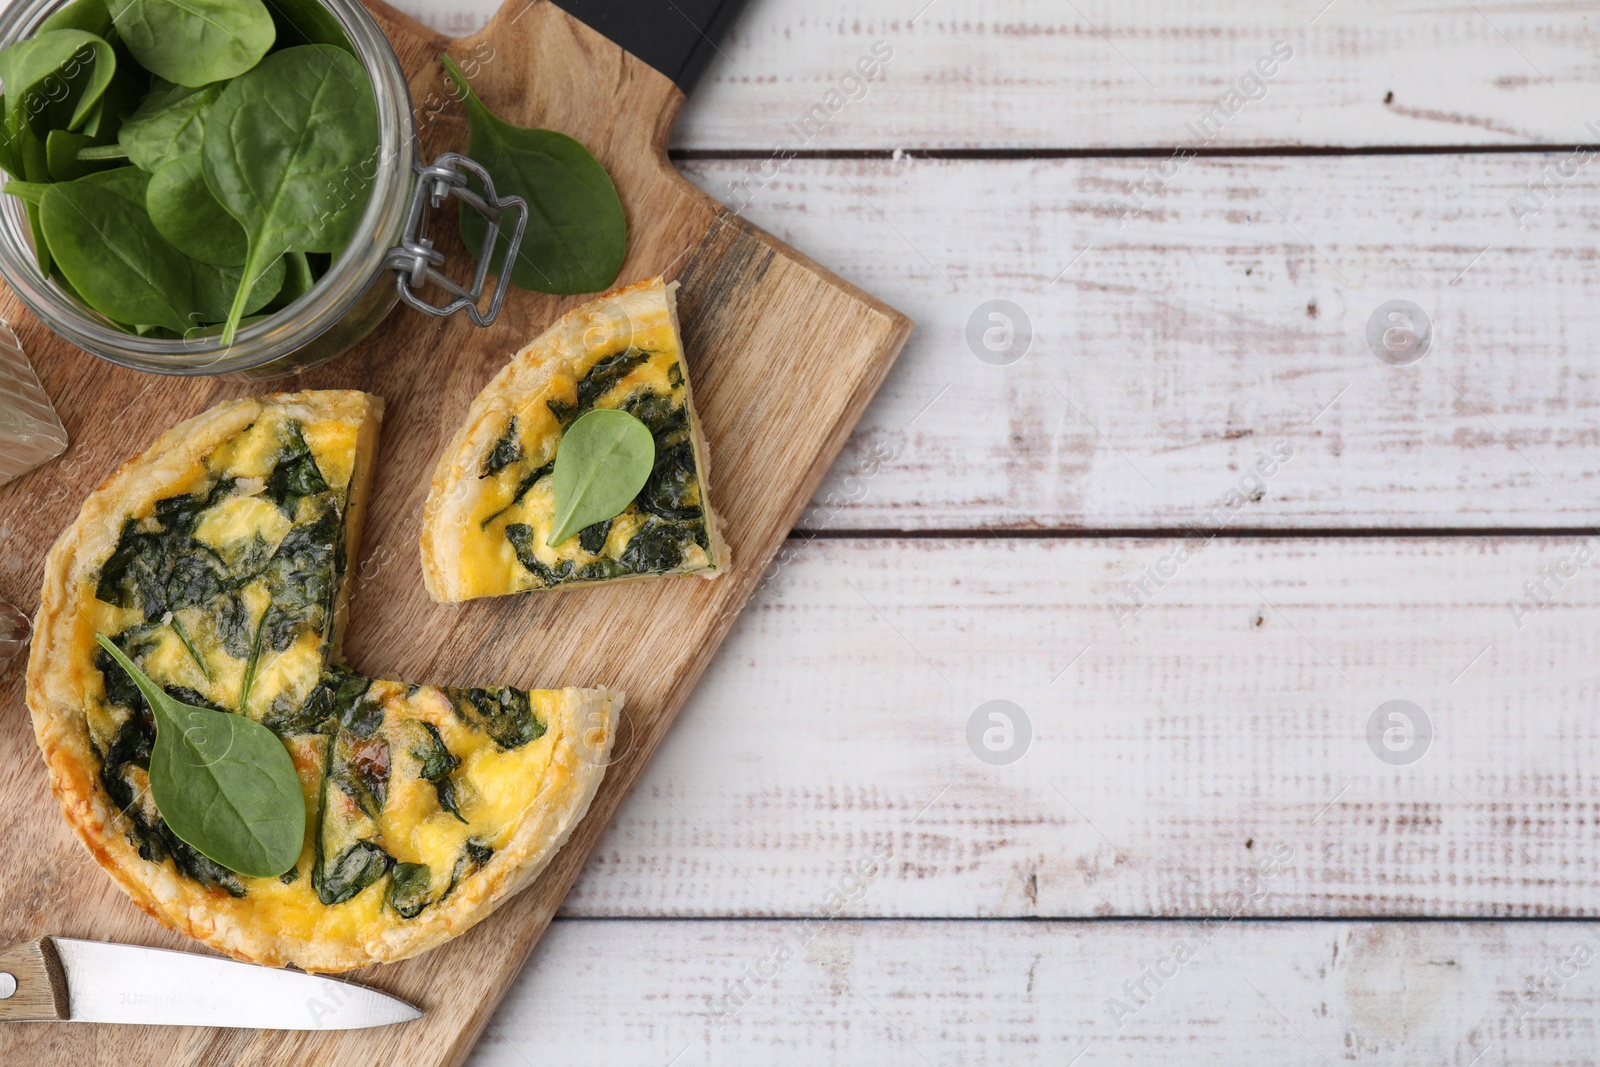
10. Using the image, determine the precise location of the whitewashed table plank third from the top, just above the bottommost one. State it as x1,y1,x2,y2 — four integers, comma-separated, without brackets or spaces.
565,537,1600,918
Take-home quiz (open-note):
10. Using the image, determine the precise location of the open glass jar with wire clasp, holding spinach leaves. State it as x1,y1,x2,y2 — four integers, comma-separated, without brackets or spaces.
0,0,526,379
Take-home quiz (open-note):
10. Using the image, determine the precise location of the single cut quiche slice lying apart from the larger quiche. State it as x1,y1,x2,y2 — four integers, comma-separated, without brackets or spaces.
422,278,728,603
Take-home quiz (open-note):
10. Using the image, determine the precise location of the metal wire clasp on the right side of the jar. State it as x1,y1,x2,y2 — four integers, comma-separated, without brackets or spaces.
384,152,528,326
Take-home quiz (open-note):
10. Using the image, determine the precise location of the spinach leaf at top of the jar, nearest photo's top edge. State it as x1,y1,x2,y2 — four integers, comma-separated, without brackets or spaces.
107,0,277,85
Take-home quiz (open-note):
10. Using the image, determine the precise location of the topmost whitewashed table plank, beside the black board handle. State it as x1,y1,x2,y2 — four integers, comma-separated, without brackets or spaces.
384,0,1600,152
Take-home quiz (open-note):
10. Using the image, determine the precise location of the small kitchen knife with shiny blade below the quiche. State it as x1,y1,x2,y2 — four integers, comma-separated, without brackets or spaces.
0,937,422,1030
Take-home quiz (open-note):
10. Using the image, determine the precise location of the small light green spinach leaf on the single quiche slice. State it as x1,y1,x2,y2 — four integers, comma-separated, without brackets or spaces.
546,408,656,547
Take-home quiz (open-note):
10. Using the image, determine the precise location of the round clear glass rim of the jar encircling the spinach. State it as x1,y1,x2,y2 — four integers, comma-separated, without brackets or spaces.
0,0,416,376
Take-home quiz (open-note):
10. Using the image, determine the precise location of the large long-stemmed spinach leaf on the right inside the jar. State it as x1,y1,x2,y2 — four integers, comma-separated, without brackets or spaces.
202,45,378,344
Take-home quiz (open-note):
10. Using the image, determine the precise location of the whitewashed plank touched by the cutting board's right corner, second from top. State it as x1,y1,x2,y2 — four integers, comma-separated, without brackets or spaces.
668,154,1600,530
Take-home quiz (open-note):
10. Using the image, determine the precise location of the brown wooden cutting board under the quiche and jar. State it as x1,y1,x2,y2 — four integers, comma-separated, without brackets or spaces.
0,0,910,1067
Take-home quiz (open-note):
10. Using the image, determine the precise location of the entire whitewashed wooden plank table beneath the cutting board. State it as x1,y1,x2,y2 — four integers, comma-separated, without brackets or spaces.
402,0,1600,1067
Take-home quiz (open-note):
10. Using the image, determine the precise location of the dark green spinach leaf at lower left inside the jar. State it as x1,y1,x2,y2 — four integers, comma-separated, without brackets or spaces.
40,166,283,336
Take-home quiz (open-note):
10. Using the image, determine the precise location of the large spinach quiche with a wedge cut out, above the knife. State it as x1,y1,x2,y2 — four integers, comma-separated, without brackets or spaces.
27,392,621,971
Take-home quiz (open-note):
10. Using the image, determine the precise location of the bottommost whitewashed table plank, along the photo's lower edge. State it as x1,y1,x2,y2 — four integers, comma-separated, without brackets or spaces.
470,921,1600,1067
